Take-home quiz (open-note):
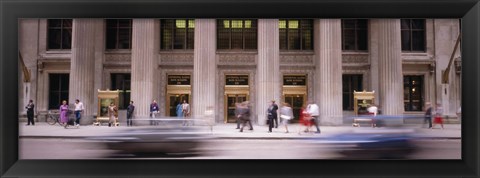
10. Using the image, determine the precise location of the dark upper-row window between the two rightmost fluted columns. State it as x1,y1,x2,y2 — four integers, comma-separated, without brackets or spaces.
342,19,368,51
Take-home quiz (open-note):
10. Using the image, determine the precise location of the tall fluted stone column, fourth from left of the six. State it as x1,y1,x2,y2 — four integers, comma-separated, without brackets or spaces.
256,19,281,125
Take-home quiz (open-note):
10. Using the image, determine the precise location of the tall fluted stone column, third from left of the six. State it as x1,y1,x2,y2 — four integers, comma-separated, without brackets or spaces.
191,19,218,123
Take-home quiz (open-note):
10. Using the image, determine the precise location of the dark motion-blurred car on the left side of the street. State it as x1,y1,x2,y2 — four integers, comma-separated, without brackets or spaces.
89,126,213,156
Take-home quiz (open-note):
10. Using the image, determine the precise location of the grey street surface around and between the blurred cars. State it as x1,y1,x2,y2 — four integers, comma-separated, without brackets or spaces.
19,138,461,159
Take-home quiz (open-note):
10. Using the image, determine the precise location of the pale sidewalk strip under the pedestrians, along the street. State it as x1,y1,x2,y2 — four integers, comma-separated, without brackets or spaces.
19,122,461,139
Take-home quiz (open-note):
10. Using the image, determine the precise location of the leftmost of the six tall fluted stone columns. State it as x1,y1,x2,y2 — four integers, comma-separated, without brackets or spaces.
68,19,103,124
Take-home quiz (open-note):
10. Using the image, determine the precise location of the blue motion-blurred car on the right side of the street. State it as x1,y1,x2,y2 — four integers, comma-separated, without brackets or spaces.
315,128,417,159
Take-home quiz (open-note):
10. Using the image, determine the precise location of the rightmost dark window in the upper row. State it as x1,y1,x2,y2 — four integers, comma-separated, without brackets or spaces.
401,19,426,52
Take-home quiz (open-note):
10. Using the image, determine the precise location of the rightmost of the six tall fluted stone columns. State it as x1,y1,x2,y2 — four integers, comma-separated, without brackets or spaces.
377,19,403,115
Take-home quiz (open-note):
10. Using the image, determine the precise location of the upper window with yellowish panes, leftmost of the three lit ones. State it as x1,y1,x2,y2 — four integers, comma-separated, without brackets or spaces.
160,19,195,50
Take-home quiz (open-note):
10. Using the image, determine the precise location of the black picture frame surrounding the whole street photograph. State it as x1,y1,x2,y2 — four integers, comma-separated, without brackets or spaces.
0,0,480,177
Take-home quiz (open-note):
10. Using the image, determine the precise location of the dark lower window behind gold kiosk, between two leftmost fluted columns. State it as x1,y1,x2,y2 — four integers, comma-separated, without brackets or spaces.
110,73,131,109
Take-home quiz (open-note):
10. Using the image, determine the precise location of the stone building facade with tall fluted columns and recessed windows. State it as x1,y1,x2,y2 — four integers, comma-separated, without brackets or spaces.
18,19,461,125
